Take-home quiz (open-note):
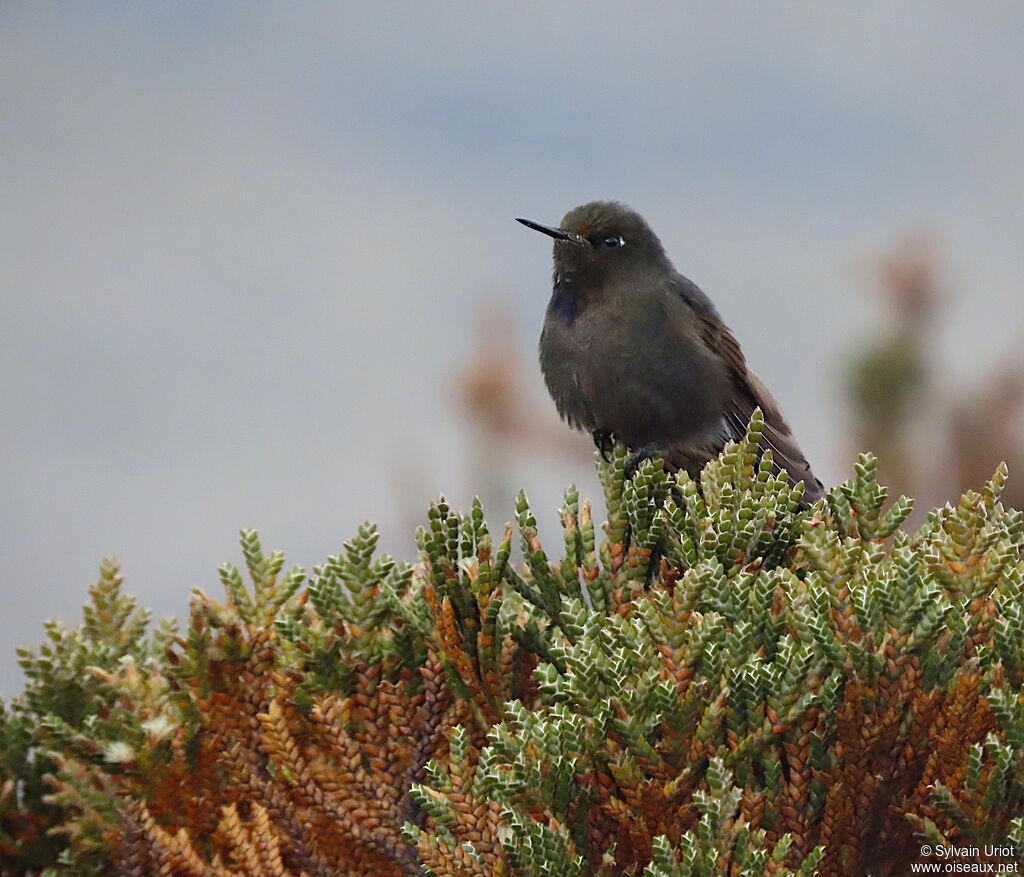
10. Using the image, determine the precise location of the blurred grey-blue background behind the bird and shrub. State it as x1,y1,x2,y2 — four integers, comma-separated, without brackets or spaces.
0,0,1024,695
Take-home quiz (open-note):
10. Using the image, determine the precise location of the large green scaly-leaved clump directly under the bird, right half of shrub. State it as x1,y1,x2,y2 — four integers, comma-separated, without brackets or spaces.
397,415,1024,874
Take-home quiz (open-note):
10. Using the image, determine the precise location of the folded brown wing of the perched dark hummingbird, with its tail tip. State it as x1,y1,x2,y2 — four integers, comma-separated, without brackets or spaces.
694,309,823,502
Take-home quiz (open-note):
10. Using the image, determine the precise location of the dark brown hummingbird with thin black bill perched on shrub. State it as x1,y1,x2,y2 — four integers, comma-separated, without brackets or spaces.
517,201,824,503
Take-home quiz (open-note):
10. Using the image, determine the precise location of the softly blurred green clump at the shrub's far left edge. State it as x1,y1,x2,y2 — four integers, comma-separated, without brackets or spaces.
0,558,175,874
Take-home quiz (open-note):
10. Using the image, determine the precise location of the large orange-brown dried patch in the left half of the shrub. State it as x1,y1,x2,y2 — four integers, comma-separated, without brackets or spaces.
116,635,466,877
